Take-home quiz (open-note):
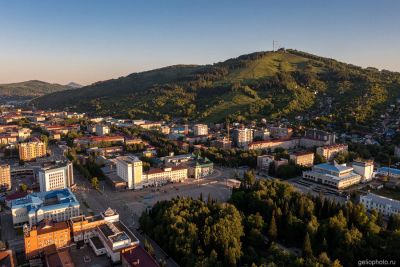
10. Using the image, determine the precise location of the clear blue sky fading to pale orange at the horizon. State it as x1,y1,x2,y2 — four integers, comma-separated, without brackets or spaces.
0,0,400,85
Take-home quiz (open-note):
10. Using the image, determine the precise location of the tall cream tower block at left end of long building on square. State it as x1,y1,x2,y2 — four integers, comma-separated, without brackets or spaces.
117,156,143,189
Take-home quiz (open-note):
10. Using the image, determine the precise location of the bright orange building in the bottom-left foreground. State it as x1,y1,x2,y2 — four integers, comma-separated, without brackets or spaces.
24,220,71,259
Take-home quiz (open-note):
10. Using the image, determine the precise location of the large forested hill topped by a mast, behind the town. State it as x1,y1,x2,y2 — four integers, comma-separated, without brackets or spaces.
34,50,400,124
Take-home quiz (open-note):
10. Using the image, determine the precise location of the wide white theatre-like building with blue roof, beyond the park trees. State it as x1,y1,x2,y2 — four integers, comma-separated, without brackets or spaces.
303,162,361,189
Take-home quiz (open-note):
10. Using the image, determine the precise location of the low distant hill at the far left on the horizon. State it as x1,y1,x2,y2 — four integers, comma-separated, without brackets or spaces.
0,80,80,97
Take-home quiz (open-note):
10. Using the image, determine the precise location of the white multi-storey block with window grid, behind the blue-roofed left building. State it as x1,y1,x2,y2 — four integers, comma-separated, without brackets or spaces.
38,161,74,192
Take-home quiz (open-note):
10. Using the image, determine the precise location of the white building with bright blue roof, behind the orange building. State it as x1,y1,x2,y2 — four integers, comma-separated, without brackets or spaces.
11,188,80,227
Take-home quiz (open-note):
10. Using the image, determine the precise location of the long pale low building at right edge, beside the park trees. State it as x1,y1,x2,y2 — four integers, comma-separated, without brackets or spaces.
360,193,400,216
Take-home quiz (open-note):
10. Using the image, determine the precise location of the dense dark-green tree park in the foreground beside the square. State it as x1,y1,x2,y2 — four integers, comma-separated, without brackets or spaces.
140,181,400,266
